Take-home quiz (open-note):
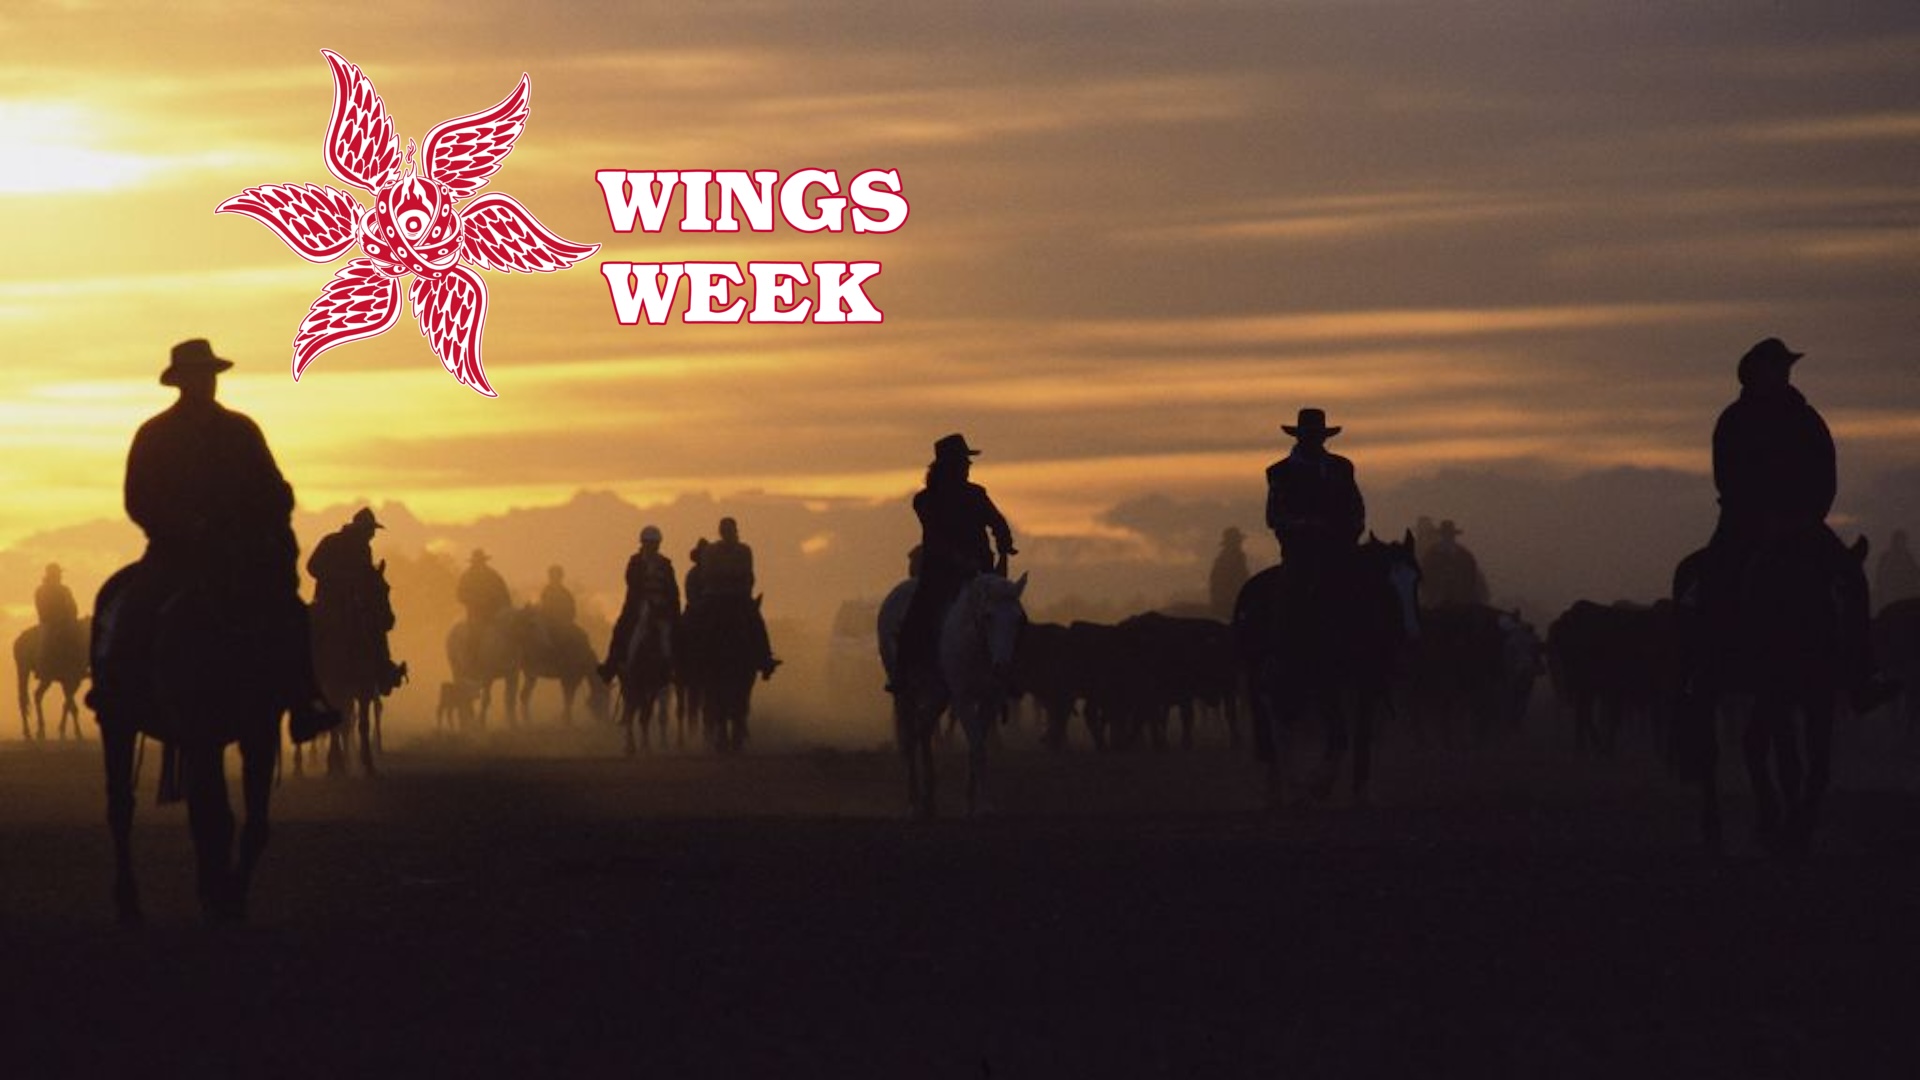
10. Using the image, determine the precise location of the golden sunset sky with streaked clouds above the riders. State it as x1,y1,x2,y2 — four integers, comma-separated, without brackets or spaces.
0,0,1920,630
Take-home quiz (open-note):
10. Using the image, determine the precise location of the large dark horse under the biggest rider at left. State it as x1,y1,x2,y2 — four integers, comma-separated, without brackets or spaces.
90,563,282,922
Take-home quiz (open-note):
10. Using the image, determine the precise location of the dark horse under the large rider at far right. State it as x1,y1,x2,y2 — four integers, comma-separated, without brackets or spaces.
1674,530,1866,853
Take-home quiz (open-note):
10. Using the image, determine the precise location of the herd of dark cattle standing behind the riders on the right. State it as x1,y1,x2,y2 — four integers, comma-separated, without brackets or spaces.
990,600,1920,755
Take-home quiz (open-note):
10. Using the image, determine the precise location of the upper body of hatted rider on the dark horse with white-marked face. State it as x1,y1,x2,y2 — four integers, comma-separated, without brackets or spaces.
1267,409,1367,573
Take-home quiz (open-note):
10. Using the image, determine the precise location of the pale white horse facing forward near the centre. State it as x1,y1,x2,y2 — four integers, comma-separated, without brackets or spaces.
879,573,1027,819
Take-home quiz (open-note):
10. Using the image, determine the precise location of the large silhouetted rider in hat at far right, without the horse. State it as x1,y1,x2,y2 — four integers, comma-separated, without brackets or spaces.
1703,338,1899,711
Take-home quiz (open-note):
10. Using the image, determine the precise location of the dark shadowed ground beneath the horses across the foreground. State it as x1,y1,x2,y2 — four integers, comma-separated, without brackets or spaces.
0,714,1920,1078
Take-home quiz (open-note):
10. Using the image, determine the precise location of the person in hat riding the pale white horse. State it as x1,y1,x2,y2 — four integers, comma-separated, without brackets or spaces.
900,434,1020,671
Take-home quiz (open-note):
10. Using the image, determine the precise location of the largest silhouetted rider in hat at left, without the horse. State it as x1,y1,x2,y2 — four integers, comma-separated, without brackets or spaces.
96,338,340,742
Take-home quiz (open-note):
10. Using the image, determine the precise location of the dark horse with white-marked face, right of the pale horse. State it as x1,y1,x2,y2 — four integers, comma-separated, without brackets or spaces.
1233,532,1421,805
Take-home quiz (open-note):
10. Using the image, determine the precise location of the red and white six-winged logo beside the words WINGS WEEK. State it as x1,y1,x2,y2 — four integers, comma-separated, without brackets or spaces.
215,50,599,398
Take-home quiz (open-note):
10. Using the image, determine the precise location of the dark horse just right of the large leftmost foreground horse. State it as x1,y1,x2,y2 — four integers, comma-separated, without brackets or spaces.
309,559,405,776
